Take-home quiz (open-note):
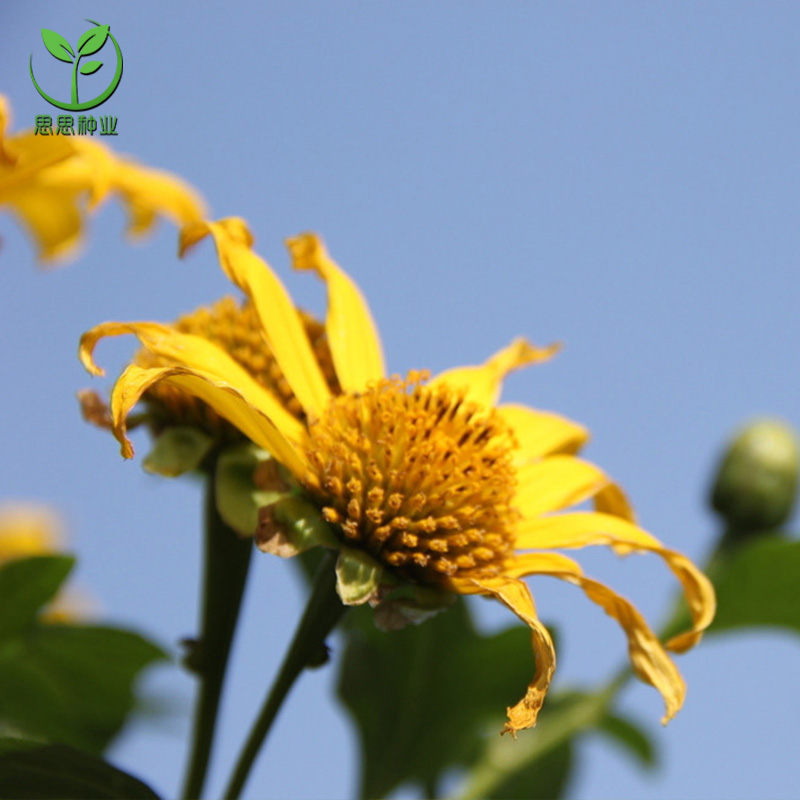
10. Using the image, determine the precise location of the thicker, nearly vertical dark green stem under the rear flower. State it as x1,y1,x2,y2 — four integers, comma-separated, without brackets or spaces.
181,462,253,800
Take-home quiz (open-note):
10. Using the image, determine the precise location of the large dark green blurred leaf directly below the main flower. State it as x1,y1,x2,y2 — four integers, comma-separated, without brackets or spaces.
338,598,533,797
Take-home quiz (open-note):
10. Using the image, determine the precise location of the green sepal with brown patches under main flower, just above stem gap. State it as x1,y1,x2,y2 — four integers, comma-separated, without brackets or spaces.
256,496,339,558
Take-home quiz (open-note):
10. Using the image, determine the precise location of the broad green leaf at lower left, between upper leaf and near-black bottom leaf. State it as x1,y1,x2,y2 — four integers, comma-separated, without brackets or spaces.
0,624,165,753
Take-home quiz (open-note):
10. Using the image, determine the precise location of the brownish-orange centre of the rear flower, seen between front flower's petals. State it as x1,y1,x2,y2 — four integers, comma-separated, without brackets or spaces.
141,297,340,438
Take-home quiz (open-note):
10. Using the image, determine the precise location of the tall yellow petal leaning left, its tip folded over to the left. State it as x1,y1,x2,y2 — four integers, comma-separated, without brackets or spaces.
181,218,330,417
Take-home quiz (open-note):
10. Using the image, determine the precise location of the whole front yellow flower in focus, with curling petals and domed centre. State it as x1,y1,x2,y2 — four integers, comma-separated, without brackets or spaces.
80,219,715,732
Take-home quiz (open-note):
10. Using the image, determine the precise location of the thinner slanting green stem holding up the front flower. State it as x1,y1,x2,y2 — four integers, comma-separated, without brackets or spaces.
224,552,347,800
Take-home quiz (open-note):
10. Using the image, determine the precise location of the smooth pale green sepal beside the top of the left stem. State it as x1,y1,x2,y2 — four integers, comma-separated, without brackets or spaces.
214,444,287,536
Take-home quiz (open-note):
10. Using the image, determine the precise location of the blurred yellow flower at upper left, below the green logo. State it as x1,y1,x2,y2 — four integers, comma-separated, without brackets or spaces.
0,95,204,261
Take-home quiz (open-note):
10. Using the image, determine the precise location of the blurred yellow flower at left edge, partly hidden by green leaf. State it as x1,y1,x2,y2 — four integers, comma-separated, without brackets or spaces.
0,503,92,622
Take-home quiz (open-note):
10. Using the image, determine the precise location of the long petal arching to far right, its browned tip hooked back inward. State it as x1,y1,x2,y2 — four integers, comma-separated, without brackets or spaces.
515,511,716,653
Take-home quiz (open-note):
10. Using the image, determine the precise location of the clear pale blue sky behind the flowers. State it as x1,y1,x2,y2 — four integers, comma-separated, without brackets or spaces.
0,0,800,799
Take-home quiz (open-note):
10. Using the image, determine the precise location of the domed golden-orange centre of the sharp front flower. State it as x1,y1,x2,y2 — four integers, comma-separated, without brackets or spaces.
305,373,517,583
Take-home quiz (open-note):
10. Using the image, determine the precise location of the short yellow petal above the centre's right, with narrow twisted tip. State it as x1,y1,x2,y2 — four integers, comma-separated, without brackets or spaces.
431,339,561,408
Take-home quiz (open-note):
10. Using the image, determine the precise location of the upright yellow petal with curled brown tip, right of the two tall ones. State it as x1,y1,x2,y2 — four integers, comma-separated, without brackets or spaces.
286,233,384,393
